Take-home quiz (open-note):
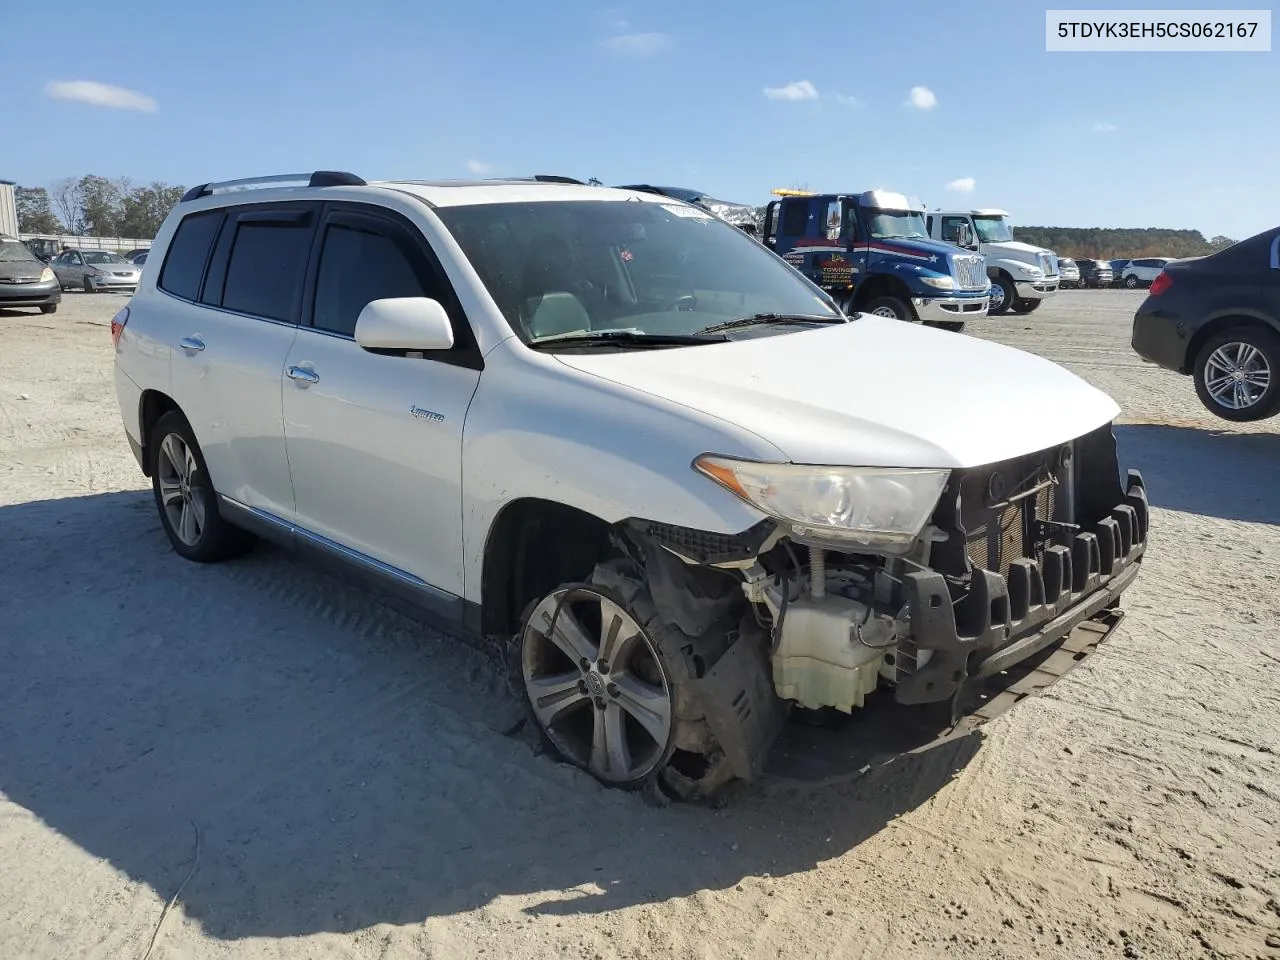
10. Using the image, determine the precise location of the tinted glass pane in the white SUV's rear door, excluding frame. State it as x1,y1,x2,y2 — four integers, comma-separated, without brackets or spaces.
221,216,311,320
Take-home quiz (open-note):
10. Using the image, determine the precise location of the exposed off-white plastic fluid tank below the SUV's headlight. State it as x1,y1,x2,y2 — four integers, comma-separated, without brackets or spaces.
772,594,895,713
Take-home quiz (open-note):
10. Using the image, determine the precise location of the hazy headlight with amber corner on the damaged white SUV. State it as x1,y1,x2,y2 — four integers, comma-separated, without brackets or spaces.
694,454,951,553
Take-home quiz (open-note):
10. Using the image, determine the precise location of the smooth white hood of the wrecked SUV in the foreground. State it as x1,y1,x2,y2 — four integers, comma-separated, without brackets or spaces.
556,316,1120,467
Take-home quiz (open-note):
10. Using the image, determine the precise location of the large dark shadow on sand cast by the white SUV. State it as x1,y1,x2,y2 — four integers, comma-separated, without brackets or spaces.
0,492,978,938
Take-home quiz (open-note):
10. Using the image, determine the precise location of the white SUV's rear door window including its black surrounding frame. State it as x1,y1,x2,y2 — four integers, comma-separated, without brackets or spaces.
201,204,316,323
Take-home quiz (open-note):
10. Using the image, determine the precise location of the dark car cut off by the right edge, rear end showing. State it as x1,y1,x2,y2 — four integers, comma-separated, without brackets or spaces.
1133,227,1280,421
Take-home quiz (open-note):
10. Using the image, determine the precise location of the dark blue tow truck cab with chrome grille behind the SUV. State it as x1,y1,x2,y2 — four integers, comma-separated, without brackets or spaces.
763,191,991,330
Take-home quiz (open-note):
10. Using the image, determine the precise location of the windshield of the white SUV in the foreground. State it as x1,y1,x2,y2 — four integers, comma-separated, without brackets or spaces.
435,200,842,346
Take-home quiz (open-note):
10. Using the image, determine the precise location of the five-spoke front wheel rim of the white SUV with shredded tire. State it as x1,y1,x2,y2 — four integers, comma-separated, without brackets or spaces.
521,588,672,783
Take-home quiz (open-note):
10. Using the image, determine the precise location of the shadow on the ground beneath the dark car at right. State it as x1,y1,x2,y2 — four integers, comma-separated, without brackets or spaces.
1115,421,1280,524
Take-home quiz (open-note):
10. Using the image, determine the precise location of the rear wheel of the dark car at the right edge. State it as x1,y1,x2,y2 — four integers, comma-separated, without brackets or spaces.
1192,326,1280,422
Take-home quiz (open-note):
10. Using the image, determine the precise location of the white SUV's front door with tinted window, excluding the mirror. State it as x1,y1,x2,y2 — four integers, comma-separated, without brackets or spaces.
284,205,480,598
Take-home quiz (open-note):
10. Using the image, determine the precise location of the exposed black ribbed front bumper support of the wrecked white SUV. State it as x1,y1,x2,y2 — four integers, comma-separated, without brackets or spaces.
895,470,1148,704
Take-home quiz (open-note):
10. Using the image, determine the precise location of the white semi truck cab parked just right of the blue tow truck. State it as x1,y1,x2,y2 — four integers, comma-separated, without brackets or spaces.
925,209,1061,316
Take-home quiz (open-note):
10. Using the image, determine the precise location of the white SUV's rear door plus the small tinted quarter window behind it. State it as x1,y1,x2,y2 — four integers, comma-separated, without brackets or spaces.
157,202,320,520
